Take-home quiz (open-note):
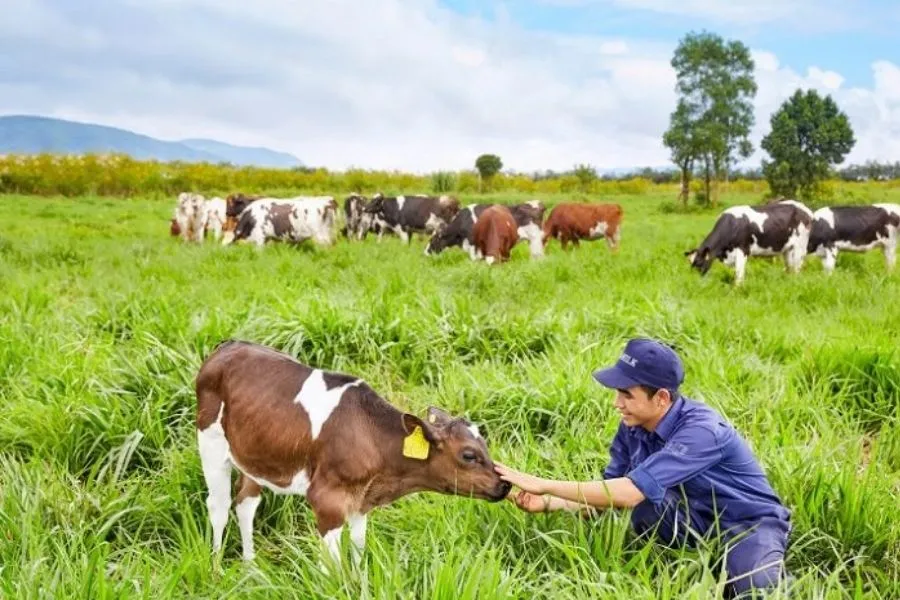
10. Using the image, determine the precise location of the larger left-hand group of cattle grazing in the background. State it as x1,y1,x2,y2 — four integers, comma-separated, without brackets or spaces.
170,192,622,264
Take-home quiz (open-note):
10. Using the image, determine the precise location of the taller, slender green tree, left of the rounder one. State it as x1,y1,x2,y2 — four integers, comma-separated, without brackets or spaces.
663,31,757,209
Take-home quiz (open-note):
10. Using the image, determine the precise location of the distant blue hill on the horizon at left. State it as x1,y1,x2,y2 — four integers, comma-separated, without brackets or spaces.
0,115,303,168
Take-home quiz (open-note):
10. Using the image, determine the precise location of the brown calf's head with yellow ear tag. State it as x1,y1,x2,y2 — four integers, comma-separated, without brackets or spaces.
403,406,512,502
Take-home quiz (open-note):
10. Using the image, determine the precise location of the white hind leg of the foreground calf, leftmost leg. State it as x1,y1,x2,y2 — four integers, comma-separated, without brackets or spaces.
197,420,231,552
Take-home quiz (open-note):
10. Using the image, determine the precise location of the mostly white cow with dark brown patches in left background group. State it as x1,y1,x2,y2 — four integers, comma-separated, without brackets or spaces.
222,196,337,248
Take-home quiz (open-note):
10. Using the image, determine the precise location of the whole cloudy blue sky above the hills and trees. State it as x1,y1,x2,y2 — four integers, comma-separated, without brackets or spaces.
0,0,900,173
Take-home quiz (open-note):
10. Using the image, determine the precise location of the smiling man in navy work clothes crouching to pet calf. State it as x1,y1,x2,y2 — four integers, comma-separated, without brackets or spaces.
496,338,791,594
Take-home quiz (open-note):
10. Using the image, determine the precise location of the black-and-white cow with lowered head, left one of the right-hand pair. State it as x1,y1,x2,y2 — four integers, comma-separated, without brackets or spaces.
684,200,813,285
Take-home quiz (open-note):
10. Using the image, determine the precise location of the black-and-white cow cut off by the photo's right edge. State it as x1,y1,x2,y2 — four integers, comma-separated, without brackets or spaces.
807,204,900,275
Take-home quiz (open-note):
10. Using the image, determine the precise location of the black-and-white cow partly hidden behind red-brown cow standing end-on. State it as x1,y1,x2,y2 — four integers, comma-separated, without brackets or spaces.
425,200,545,260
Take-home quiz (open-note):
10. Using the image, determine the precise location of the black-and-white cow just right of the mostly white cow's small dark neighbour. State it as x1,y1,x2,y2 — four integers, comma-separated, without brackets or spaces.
359,193,459,244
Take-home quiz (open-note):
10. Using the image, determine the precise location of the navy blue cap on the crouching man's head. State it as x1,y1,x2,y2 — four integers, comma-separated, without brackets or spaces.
593,338,684,391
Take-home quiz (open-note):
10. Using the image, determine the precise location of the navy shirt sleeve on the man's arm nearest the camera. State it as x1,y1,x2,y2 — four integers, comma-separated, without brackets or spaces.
626,425,727,504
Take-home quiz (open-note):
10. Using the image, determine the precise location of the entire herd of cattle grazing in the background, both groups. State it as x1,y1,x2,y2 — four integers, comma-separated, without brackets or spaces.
171,192,900,285
